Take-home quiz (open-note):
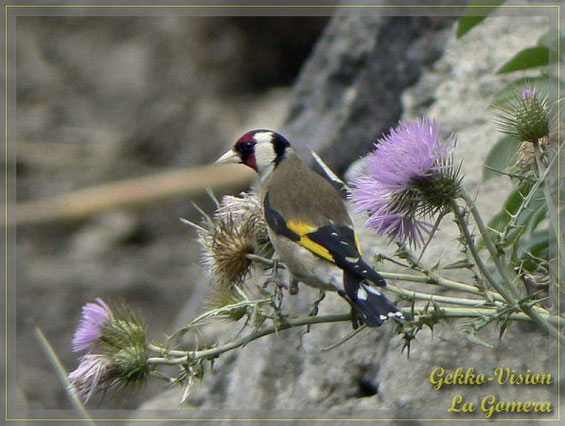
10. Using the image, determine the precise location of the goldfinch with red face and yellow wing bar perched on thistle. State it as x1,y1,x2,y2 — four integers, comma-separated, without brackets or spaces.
216,129,404,328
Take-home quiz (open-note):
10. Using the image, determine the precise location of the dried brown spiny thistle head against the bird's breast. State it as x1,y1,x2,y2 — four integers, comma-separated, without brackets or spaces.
198,193,273,286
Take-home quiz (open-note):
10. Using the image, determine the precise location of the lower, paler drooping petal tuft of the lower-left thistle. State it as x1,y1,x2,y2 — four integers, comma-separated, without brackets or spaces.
69,354,111,403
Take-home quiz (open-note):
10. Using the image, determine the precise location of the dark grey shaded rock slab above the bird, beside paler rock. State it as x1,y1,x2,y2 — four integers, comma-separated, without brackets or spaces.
283,13,452,173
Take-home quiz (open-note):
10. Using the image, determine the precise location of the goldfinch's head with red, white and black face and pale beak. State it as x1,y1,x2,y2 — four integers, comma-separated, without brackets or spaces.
216,129,291,177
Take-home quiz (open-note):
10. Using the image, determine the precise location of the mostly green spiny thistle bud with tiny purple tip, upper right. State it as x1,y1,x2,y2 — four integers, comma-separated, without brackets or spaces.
496,87,554,142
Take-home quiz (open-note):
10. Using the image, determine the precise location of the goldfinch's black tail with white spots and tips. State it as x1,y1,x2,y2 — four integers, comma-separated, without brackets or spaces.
343,271,404,327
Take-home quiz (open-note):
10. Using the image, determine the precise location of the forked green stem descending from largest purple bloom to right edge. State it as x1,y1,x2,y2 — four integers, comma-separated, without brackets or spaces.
452,188,565,340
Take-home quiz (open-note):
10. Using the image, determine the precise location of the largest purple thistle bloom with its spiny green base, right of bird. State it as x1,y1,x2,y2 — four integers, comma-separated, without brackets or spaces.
350,118,461,246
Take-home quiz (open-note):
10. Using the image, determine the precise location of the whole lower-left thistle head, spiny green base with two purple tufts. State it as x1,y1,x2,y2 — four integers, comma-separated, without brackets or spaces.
69,299,150,402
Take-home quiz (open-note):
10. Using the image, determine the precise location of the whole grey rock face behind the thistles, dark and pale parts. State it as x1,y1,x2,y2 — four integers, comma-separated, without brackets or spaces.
132,10,557,424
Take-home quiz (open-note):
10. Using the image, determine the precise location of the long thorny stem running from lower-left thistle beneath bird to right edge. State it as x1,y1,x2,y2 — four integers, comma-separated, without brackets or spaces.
148,307,557,365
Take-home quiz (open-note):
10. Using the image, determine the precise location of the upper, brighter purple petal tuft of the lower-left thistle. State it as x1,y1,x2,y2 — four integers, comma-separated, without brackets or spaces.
73,298,113,352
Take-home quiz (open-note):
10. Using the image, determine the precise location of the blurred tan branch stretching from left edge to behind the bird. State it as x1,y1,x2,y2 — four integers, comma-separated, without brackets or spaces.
8,165,254,226
